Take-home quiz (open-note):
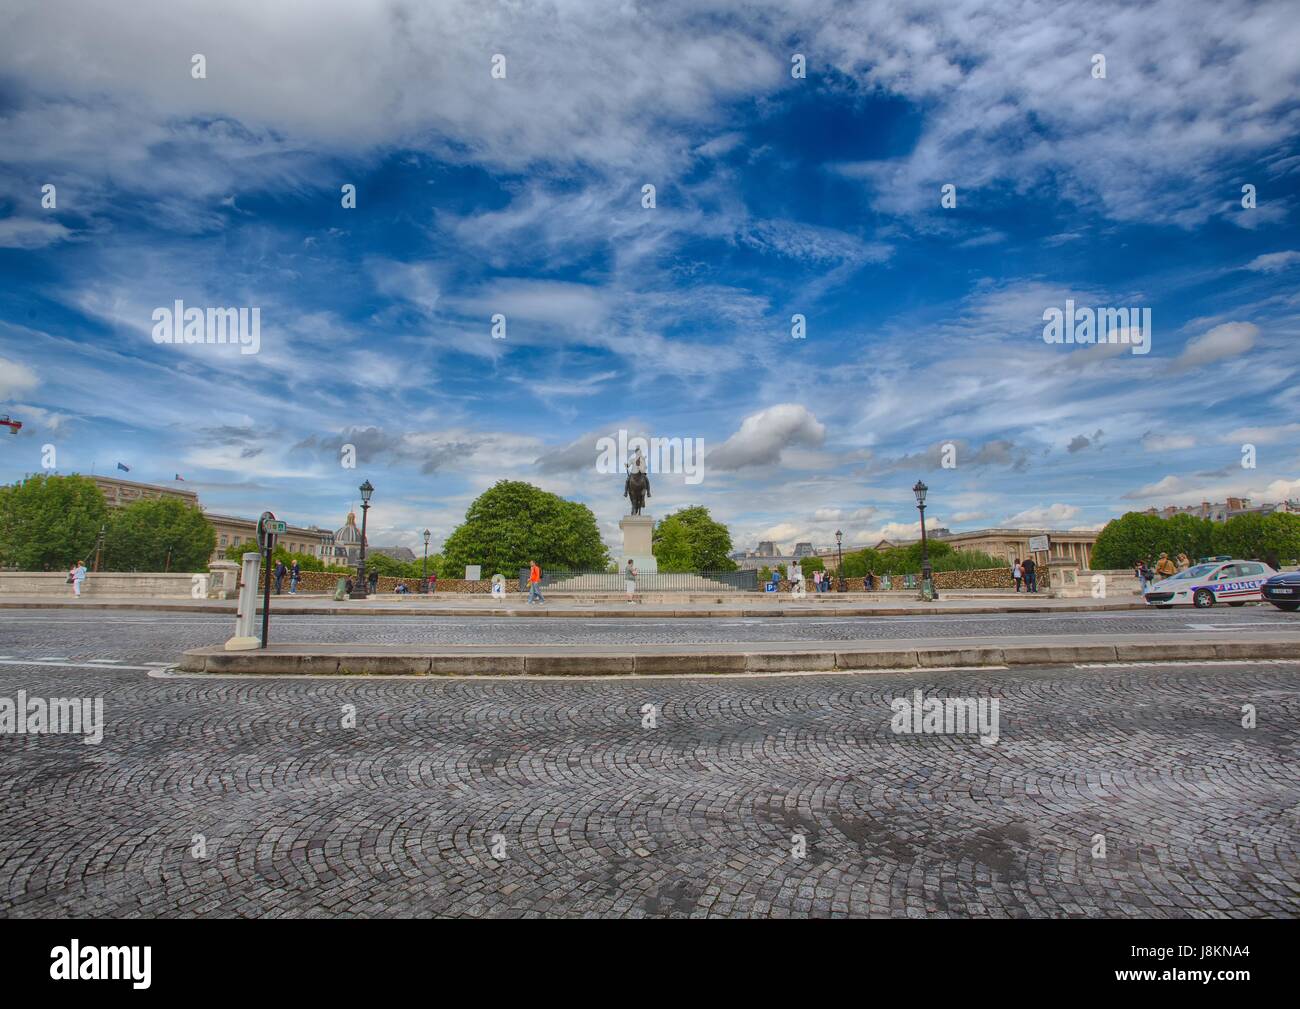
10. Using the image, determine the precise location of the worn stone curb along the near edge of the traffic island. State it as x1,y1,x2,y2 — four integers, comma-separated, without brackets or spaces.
178,641,1296,676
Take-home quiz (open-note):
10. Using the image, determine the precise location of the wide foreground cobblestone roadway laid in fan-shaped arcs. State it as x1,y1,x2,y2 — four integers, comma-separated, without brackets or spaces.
0,625,1300,917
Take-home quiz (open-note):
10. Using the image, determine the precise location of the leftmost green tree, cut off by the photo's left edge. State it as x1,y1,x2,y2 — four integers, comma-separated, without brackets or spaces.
0,473,108,571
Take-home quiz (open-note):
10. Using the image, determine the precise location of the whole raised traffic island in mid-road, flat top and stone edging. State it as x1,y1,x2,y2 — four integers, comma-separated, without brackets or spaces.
178,632,1300,676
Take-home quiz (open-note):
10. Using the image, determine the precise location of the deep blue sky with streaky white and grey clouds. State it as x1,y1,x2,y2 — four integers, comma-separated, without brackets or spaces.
0,0,1300,546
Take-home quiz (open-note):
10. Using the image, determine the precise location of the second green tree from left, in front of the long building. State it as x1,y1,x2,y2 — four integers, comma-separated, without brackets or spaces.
101,498,217,571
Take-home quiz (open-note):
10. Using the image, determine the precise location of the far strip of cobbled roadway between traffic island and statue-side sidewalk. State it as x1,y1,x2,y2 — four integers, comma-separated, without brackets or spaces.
0,606,1300,662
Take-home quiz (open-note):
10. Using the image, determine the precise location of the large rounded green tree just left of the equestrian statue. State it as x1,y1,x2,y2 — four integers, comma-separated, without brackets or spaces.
442,480,610,579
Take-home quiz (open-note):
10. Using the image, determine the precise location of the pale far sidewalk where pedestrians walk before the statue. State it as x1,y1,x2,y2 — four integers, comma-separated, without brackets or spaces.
0,593,1147,618
